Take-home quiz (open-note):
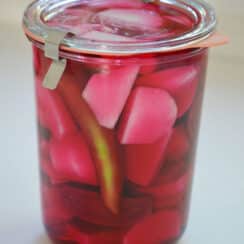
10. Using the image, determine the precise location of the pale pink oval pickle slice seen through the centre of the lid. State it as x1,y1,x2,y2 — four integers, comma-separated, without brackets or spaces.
94,8,163,30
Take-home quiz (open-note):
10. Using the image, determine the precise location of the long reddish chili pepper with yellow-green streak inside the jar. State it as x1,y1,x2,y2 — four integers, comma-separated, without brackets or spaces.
58,76,123,214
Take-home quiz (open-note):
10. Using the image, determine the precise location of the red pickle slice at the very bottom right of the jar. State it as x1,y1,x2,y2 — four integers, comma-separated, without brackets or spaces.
124,210,181,244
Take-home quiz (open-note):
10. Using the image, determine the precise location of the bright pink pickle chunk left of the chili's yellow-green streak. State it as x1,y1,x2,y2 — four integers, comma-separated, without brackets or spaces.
50,134,97,185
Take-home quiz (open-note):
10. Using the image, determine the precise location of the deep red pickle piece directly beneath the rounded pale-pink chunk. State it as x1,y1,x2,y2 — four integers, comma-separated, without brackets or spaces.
125,133,170,186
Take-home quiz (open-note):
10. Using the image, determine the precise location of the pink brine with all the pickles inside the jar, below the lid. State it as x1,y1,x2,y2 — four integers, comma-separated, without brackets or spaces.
34,1,207,244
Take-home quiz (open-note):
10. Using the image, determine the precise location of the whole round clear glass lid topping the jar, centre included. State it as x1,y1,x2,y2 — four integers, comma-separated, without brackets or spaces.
23,0,216,55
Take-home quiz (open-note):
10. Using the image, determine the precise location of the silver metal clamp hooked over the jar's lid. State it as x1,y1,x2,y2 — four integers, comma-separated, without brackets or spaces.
42,30,68,90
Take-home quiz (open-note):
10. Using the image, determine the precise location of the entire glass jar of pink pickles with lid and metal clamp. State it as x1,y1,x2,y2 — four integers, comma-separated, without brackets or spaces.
23,0,215,244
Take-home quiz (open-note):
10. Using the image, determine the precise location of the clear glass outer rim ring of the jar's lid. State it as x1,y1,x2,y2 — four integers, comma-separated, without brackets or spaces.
23,0,217,56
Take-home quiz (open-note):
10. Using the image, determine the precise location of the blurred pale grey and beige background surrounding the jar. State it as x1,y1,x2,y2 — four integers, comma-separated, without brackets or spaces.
0,0,244,244
